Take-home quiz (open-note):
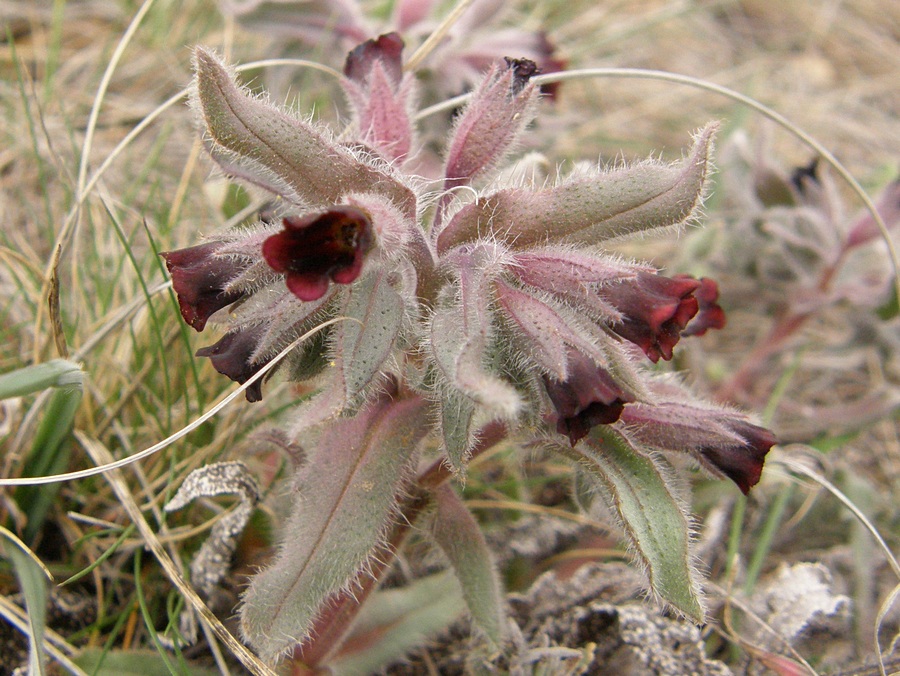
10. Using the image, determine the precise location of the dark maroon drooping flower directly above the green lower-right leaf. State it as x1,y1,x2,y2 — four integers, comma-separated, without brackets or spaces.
544,349,634,446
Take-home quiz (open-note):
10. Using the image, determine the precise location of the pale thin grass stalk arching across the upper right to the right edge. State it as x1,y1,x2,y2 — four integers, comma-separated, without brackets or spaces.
415,68,900,297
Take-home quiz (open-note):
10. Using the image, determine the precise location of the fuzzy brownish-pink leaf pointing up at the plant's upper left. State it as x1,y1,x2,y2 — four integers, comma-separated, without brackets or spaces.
195,48,415,212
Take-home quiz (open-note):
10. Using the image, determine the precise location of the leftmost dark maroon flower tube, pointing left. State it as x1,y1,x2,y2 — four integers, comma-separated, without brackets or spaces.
160,242,244,331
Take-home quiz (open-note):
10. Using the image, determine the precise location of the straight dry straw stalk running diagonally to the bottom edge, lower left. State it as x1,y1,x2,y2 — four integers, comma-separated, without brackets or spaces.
75,434,274,676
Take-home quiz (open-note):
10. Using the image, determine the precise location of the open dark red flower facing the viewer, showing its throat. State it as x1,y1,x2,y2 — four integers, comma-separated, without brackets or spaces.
262,205,373,301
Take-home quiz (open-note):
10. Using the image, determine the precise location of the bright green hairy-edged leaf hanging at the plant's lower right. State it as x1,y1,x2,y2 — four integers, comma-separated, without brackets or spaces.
551,425,704,622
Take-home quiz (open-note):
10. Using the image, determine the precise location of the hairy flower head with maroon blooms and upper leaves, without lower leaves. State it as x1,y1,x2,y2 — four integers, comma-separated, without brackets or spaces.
163,34,775,492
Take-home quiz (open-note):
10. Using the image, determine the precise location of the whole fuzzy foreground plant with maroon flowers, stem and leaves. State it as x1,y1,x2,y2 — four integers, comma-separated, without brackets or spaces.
163,34,775,667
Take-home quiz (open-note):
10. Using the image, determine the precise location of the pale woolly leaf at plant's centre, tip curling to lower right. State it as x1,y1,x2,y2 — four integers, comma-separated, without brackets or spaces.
430,253,521,417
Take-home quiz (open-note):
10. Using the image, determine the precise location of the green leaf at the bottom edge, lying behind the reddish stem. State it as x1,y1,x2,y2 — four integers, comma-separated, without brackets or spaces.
328,573,465,676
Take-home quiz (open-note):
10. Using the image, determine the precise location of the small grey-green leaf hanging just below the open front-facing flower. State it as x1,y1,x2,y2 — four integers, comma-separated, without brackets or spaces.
335,271,404,402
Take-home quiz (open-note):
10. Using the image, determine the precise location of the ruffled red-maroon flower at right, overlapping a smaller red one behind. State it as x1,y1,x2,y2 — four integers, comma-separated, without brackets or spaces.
601,272,704,364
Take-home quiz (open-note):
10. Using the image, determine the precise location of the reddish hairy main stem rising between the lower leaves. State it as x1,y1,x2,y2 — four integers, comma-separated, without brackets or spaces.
292,421,508,676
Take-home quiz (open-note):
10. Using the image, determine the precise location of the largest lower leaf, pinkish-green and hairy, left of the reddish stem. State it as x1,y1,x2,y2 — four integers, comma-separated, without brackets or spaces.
241,394,428,661
